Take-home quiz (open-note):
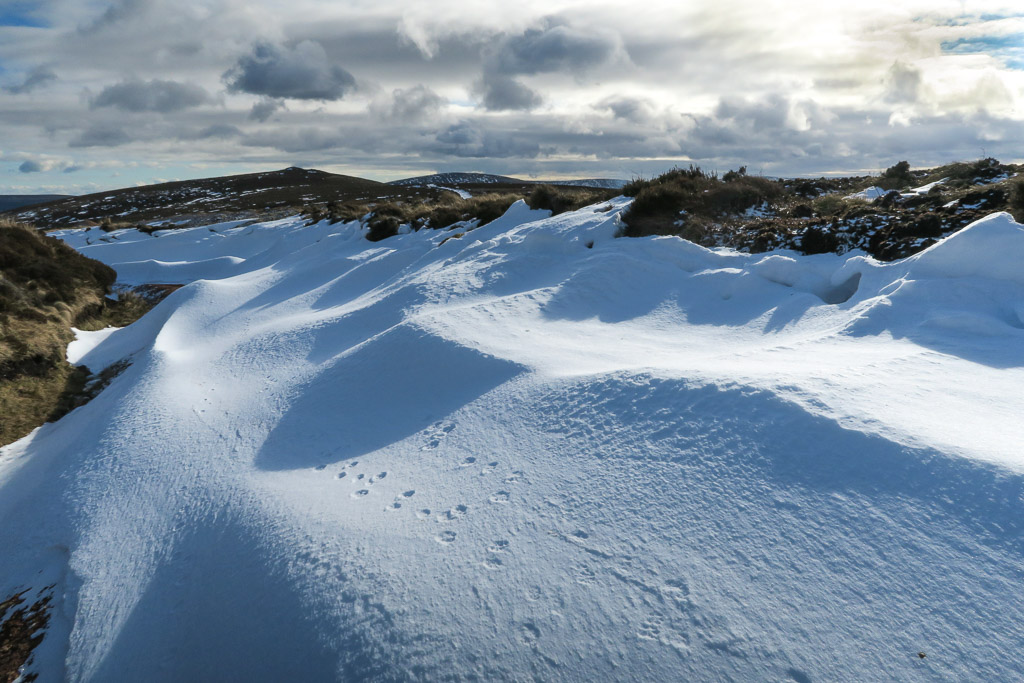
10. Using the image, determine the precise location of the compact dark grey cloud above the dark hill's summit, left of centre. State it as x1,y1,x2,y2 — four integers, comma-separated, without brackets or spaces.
223,40,355,100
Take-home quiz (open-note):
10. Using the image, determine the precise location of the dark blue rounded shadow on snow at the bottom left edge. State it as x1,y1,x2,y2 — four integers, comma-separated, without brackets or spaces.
84,514,364,683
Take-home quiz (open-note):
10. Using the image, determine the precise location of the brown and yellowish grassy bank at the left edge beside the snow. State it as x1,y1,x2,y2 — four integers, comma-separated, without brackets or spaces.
0,222,153,445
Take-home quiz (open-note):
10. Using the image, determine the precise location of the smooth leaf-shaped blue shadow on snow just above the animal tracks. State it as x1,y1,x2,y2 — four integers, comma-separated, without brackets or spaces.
255,325,523,470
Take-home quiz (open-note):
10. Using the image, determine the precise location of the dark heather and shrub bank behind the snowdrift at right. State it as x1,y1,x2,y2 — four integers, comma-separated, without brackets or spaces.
624,159,1024,260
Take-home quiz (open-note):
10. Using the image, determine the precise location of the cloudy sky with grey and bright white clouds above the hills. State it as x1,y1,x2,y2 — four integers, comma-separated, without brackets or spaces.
0,0,1024,194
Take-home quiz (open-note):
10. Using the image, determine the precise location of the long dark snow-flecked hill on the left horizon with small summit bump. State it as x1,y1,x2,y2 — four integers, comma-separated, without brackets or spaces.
6,167,423,228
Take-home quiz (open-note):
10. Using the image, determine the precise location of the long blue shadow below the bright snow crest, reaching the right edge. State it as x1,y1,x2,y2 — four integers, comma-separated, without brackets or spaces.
539,375,1024,556
